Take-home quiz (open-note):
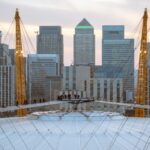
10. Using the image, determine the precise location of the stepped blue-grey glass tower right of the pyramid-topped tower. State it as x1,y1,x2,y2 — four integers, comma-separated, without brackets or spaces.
102,25,134,99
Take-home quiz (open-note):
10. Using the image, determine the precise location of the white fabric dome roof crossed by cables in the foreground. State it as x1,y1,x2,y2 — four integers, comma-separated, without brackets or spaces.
0,112,150,150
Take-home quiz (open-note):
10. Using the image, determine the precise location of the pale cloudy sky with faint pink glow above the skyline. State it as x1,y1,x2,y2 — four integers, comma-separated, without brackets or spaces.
0,0,150,65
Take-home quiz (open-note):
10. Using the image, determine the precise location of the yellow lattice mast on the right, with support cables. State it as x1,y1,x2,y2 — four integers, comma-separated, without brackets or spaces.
135,9,148,117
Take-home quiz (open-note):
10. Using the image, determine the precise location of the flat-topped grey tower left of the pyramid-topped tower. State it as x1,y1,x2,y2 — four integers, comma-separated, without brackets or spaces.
37,26,64,75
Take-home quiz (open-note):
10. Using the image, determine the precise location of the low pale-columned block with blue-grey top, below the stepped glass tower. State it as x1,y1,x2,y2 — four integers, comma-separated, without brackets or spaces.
94,65,124,102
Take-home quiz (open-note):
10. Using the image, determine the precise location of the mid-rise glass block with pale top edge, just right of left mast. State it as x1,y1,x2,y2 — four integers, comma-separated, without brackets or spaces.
27,54,61,103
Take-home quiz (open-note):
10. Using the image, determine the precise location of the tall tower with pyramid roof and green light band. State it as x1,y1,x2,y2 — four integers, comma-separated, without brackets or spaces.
74,19,95,65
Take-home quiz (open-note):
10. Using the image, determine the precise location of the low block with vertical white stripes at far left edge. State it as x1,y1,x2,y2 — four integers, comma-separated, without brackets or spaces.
0,65,16,107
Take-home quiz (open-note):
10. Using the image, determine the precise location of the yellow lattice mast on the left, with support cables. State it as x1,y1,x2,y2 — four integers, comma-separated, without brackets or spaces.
15,9,27,117
